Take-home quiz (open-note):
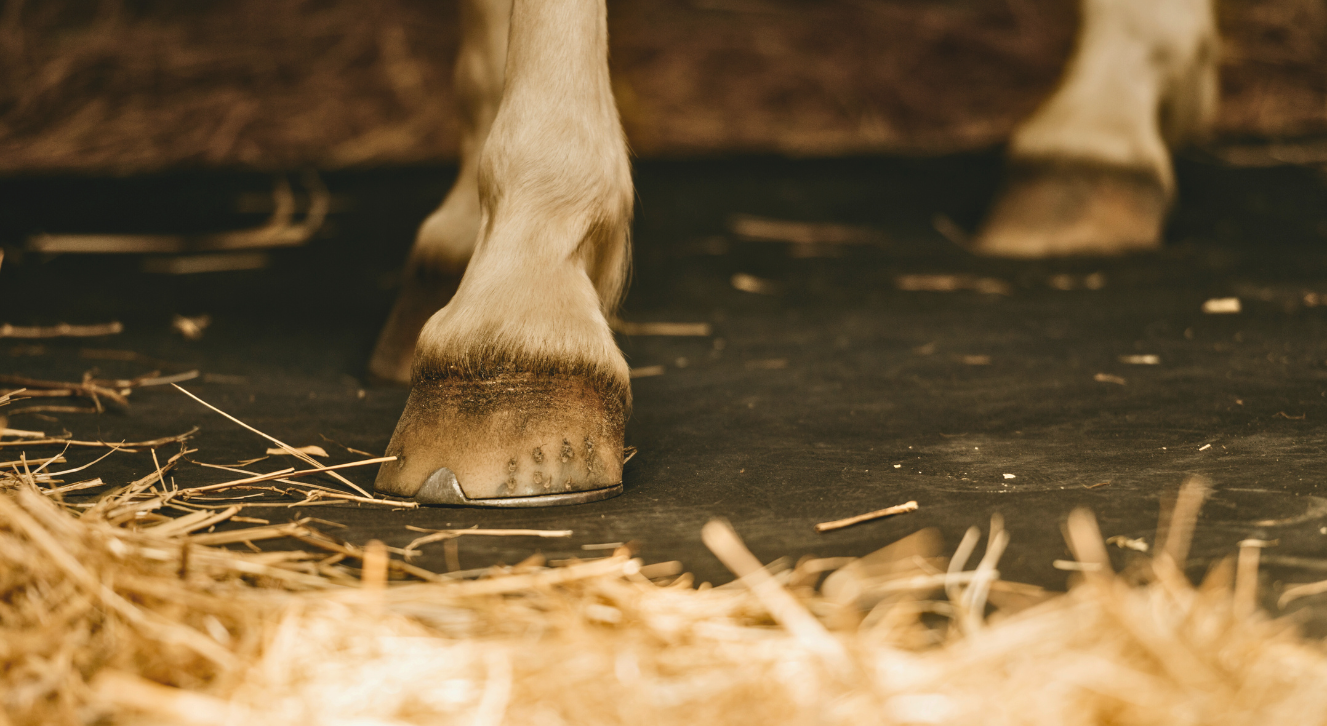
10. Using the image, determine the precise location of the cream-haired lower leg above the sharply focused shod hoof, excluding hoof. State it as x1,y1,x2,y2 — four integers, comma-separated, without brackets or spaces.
415,0,633,382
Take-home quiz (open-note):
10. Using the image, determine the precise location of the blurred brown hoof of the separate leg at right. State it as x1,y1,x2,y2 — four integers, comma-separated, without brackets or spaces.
973,162,1170,257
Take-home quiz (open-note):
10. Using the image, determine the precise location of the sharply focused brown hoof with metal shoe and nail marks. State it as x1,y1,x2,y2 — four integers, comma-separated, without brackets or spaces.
374,373,626,507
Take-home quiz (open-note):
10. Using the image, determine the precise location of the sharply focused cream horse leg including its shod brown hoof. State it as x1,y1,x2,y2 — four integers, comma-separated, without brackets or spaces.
377,0,633,500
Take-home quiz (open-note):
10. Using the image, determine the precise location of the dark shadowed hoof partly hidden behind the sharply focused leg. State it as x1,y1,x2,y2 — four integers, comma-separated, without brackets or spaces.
369,272,460,386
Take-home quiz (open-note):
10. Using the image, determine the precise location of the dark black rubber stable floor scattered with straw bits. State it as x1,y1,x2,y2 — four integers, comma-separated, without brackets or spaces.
0,153,1327,617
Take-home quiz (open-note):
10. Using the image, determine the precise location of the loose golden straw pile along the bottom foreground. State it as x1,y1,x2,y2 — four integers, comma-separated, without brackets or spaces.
0,390,1327,726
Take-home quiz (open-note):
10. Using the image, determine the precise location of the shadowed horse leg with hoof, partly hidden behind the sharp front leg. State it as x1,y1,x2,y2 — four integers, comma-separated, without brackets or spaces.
369,0,511,384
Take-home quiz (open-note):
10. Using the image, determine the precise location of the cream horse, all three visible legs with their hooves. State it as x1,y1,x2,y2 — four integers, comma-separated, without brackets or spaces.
369,0,1218,507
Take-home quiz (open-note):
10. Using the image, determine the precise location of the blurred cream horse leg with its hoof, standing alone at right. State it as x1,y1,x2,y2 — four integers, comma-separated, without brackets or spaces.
977,0,1217,256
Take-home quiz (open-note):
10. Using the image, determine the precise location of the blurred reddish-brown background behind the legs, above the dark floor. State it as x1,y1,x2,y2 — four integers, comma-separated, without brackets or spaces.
0,0,1327,174
